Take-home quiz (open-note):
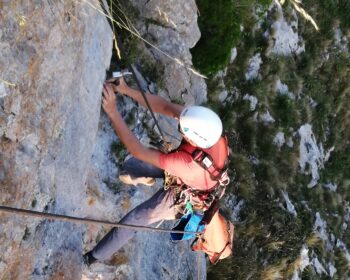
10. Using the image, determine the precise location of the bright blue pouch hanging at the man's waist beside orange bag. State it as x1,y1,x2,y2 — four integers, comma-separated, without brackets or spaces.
170,213,204,241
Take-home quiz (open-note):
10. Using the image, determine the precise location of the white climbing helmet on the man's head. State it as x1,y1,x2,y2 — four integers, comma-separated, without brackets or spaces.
180,106,222,149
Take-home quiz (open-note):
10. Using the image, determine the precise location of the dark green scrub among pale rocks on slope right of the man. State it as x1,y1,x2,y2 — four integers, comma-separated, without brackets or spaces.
208,0,350,280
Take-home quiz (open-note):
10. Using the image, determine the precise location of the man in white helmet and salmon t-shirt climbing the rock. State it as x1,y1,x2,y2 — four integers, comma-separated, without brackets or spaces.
83,78,228,265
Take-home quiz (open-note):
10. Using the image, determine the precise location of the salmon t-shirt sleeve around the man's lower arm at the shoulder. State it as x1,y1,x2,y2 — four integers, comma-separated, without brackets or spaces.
159,151,192,178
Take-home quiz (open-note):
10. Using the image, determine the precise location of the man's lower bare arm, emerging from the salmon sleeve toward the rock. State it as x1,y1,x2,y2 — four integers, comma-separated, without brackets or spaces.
102,84,161,167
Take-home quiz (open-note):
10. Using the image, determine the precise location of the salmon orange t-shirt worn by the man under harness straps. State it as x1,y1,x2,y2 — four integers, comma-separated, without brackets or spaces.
159,137,228,191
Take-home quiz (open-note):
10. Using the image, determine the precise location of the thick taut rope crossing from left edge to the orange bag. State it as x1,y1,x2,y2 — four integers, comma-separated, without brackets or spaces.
0,206,201,236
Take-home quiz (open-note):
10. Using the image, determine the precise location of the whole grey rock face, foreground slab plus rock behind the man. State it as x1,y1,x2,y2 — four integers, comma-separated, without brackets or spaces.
0,0,206,279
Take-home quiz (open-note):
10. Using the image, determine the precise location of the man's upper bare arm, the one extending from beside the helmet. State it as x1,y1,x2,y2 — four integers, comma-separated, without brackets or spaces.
107,78,184,119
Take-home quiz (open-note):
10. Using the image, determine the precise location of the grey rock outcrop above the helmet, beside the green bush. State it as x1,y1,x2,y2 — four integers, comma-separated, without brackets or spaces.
134,0,206,105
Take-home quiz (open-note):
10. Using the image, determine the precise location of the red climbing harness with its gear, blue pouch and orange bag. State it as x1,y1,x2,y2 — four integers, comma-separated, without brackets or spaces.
164,134,234,264
